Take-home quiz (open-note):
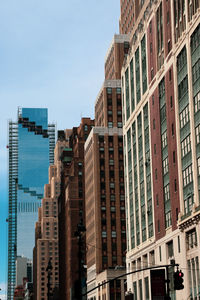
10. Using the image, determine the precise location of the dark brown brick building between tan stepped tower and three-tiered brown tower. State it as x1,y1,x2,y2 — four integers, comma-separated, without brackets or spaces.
58,118,94,300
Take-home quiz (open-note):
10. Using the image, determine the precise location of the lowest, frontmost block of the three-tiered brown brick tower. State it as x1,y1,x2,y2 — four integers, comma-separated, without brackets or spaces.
85,127,126,299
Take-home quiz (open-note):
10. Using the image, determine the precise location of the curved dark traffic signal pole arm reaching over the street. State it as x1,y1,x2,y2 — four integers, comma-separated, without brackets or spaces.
82,264,179,300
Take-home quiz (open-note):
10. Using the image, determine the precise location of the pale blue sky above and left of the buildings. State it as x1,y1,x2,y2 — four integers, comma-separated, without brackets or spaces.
0,0,120,300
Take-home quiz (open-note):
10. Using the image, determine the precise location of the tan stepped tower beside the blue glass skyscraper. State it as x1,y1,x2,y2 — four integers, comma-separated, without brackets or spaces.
33,139,65,300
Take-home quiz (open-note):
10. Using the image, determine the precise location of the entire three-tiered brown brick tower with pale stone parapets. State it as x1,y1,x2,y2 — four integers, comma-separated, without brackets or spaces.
85,34,129,300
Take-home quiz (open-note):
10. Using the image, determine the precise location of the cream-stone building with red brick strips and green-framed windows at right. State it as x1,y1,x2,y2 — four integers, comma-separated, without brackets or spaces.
121,0,200,300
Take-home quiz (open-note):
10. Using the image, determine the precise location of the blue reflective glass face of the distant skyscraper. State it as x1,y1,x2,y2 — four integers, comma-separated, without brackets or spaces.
17,108,49,259
